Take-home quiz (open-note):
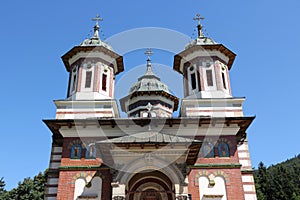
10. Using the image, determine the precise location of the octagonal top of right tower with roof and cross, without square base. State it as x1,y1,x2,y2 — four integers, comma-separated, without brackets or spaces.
174,14,236,98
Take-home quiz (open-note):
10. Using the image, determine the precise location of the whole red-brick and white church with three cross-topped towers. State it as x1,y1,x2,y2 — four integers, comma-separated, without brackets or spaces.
43,14,256,200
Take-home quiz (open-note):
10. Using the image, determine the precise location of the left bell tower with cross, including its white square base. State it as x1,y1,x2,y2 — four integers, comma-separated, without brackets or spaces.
55,15,124,119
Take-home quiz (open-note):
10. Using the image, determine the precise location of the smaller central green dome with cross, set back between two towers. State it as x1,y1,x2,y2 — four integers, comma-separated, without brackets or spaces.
120,49,179,118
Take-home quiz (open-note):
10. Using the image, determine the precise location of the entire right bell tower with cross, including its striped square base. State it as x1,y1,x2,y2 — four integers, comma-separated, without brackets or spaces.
173,14,244,117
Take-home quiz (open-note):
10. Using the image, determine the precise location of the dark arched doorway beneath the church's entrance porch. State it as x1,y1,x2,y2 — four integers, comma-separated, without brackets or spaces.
126,171,175,200
